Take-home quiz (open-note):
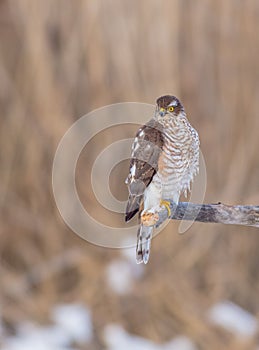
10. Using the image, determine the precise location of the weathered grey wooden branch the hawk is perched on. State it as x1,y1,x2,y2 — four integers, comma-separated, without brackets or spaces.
156,201,259,227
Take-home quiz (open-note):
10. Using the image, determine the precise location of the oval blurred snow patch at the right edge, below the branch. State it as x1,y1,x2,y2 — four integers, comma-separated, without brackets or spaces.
208,301,258,337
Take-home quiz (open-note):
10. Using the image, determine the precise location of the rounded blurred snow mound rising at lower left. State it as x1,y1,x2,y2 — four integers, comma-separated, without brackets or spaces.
52,304,93,344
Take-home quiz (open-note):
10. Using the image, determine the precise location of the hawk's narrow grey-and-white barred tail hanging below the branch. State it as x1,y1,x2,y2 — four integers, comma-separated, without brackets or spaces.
136,224,153,264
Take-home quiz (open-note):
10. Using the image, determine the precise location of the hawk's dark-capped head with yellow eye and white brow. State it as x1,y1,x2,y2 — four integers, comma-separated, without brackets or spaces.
156,95,185,119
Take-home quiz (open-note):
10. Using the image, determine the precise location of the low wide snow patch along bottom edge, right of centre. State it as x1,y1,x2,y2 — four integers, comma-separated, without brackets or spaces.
103,324,196,350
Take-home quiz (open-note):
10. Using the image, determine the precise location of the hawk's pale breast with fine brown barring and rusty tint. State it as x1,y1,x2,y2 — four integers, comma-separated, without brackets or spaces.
154,116,199,203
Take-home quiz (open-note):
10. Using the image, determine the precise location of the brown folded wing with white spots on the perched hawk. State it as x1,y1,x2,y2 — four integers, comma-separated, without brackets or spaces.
125,119,163,221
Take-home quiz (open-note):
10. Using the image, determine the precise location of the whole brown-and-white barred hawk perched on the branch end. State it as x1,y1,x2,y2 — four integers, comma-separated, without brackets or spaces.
125,95,200,264
